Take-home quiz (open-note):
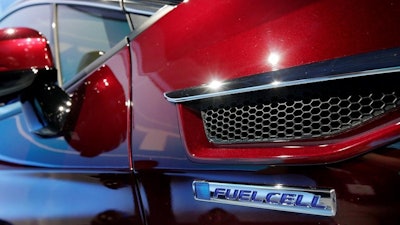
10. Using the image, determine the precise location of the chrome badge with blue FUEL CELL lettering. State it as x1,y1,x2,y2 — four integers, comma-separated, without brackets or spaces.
193,181,336,216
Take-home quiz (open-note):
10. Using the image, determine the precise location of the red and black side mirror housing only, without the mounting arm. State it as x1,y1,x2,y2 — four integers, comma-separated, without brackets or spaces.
0,28,54,99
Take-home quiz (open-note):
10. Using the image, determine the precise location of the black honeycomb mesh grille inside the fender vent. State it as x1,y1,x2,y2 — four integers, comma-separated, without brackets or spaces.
189,74,400,144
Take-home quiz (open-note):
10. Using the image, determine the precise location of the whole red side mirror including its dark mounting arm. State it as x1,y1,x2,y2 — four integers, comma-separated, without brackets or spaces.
0,28,71,136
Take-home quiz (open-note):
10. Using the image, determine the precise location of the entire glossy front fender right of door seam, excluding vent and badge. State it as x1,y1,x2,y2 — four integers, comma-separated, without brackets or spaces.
131,0,400,224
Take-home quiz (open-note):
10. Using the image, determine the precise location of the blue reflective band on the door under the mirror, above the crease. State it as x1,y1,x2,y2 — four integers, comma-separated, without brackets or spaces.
0,114,129,169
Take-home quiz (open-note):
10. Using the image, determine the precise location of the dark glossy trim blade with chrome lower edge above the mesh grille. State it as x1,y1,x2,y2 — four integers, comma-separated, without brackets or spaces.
164,48,400,103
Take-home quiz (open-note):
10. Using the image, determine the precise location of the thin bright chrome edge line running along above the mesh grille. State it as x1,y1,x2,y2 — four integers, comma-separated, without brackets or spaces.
164,66,400,103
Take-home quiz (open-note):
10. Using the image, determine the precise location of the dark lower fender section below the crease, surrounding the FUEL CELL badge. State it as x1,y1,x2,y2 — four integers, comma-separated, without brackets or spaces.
138,147,400,225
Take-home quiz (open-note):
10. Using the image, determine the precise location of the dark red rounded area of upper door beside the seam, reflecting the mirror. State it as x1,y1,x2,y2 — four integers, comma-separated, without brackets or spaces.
65,48,130,157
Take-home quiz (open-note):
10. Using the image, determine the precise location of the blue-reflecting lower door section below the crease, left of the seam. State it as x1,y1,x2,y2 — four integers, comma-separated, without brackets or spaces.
0,169,141,224
